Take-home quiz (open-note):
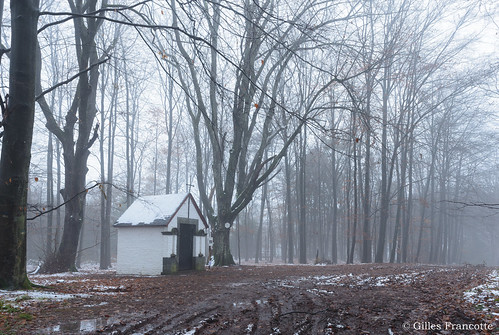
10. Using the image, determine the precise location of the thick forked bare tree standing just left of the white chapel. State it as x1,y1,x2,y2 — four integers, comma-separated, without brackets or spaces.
38,0,107,272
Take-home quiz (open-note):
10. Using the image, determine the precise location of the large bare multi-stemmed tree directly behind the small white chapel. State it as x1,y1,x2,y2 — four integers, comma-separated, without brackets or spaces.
170,1,360,265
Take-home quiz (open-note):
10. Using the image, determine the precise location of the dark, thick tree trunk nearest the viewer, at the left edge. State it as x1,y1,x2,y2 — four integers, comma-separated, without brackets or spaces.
0,0,39,289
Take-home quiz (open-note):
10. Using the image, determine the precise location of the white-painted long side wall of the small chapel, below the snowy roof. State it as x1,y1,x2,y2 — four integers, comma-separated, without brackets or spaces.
116,227,167,275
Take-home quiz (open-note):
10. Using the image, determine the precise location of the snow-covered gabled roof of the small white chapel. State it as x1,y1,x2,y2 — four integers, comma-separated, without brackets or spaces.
114,193,207,227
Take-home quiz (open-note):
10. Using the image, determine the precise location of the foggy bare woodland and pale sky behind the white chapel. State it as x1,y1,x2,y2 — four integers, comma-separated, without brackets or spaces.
0,0,499,271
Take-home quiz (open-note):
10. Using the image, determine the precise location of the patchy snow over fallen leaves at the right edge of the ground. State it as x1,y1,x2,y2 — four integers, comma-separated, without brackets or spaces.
464,270,499,317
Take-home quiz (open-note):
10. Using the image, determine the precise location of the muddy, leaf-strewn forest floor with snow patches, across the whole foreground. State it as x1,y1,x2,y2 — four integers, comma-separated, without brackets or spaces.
0,264,499,335
